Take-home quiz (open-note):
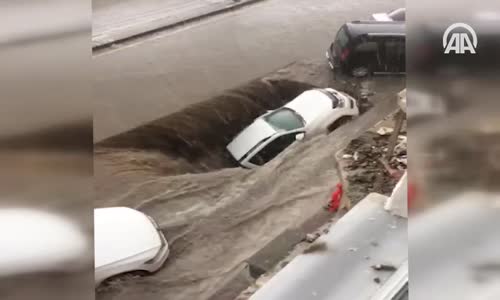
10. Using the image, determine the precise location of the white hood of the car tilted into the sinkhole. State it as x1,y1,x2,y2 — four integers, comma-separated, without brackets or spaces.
285,90,333,126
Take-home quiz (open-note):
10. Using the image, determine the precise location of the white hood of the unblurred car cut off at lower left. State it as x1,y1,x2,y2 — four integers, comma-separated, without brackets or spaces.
94,207,162,269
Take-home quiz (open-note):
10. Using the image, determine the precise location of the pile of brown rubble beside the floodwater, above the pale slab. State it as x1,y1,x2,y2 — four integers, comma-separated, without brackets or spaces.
340,128,407,204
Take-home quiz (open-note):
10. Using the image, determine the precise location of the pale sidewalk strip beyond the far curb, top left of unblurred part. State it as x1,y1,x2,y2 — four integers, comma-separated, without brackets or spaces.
92,0,263,48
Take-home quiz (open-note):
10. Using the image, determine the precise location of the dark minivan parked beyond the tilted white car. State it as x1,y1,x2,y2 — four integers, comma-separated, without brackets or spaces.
326,21,406,76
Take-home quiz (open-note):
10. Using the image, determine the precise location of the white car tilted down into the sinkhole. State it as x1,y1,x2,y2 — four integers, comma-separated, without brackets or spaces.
227,88,359,168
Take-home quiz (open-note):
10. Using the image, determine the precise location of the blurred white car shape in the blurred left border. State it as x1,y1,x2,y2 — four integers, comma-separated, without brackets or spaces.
0,207,91,277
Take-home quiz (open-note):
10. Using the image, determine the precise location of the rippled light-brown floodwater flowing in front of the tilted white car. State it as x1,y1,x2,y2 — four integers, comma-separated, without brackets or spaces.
95,60,404,300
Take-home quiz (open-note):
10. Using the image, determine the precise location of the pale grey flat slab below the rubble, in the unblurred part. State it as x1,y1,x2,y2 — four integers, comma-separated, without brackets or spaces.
251,193,408,300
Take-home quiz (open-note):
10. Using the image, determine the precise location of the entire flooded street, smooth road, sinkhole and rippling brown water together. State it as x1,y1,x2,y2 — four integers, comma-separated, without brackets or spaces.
94,0,404,300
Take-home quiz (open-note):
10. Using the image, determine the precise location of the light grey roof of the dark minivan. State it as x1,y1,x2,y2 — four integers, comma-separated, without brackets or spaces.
344,21,406,38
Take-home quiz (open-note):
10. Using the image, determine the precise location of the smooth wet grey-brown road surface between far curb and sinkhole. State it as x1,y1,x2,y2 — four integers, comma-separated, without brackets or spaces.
93,0,404,141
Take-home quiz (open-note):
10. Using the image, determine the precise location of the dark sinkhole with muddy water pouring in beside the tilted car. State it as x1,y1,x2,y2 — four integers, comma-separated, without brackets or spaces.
95,79,314,175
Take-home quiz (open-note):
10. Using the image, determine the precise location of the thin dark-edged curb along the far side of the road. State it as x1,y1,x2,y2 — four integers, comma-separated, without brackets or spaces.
92,0,265,52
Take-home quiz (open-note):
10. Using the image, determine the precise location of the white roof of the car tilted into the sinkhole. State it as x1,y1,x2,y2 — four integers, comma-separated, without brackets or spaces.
227,117,277,161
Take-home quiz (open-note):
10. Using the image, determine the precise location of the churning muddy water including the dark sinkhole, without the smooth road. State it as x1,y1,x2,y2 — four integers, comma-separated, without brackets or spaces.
95,59,401,300
